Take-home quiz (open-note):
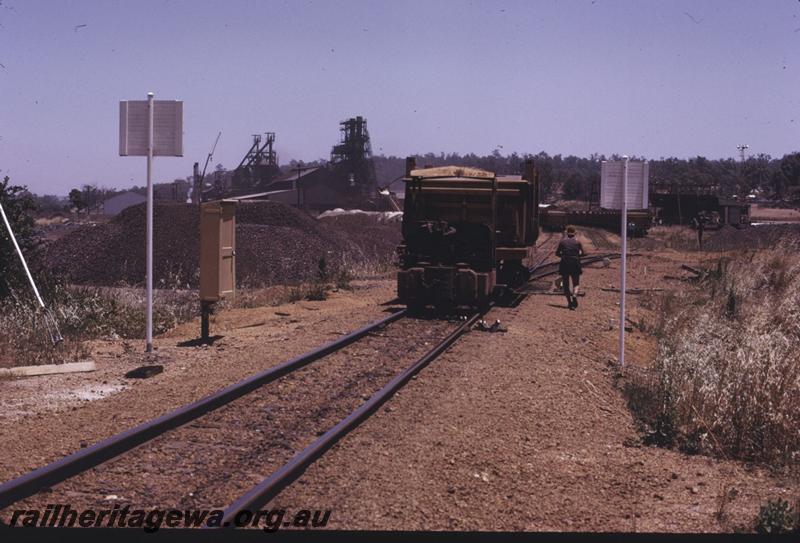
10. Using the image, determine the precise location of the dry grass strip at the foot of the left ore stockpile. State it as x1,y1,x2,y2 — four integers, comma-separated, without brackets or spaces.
0,257,392,367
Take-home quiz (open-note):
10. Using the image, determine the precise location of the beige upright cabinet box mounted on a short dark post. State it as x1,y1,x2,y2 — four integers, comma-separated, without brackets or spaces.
200,200,238,303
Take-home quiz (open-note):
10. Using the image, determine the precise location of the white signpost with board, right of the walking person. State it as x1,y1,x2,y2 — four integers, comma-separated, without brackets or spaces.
600,156,649,368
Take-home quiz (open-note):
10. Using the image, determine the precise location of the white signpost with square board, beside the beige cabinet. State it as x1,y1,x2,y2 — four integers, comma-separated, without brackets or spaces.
119,92,183,353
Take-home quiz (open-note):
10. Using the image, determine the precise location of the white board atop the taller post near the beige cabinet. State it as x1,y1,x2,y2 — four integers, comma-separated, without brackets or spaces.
119,100,183,156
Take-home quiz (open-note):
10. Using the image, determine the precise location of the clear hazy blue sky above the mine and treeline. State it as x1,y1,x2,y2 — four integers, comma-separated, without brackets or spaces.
0,0,800,194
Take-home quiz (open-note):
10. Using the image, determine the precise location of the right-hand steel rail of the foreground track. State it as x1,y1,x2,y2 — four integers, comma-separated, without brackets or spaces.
216,305,484,527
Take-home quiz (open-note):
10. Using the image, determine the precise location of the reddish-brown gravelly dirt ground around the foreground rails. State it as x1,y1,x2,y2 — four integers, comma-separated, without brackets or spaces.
0,227,800,532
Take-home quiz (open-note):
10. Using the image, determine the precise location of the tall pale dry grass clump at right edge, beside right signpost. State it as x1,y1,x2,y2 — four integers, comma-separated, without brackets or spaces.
628,246,800,468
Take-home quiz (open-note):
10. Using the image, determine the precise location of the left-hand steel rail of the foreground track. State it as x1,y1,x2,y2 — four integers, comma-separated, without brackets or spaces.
0,309,407,509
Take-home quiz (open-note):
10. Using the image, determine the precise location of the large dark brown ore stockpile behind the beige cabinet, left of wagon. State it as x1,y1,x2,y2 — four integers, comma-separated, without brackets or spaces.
39,201,400,288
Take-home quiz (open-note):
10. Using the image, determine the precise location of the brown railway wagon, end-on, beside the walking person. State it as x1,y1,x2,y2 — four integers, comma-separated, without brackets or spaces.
397,158,539,308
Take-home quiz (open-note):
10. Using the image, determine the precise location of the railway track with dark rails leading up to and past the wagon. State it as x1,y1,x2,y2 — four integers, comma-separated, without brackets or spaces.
0,253,613,525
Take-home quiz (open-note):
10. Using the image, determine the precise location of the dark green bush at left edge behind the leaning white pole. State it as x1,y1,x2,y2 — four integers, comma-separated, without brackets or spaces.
0,176,36,299
